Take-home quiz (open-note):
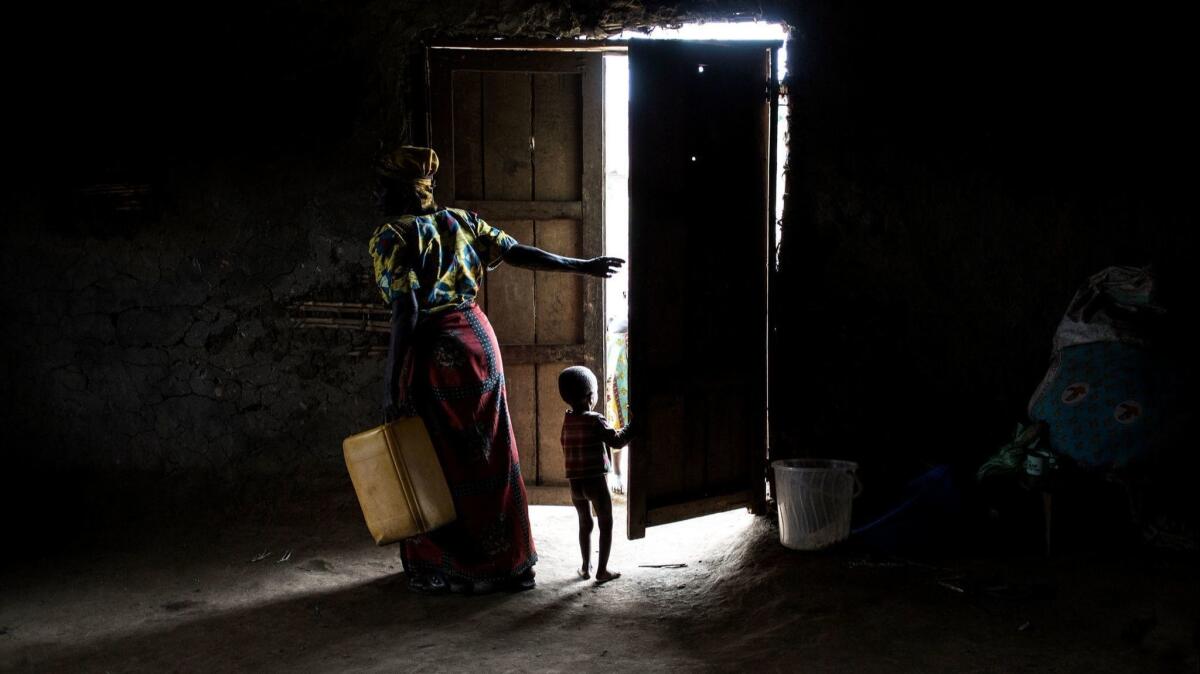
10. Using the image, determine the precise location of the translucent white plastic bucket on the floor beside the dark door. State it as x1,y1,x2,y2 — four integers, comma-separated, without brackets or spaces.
770,458,862,550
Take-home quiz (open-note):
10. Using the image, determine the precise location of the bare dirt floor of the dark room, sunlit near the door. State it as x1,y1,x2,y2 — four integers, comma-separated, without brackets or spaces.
0,482,1200,673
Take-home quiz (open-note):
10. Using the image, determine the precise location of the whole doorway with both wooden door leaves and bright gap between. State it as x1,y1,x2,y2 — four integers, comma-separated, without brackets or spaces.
428,24,786,537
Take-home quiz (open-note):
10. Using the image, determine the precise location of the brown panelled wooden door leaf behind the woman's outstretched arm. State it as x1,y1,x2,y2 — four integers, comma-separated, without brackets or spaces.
430,48,604,504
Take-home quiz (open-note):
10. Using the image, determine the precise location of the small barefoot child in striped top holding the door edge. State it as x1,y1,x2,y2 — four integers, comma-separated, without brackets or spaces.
558,366,630,583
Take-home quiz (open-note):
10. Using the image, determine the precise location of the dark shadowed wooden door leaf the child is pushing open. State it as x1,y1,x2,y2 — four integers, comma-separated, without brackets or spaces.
629,41,776,538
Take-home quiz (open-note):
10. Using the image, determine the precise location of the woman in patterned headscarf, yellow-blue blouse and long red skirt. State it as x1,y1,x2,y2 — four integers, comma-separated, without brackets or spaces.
370,146,624,591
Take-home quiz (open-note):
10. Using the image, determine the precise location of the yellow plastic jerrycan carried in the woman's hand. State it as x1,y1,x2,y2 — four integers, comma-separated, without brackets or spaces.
342,416,455,546
